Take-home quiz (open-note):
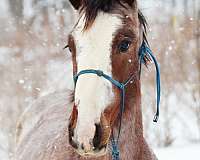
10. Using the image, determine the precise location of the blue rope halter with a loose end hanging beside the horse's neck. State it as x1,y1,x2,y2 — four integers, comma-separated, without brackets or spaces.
74,41,160,160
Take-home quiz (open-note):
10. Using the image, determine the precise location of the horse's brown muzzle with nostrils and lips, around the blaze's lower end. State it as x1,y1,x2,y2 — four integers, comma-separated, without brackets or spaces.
68,110,111,157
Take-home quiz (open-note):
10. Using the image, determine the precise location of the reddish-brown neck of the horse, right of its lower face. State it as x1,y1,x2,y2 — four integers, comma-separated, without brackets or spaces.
115,81,154,160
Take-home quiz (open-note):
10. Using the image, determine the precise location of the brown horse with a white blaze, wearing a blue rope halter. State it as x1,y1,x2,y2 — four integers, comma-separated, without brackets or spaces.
15,0,160,160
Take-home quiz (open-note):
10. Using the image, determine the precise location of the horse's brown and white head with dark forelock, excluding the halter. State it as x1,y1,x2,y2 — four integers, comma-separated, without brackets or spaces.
68,0,144,156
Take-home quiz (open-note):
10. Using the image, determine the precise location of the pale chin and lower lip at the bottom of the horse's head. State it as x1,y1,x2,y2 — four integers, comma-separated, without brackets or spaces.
75,147,107,158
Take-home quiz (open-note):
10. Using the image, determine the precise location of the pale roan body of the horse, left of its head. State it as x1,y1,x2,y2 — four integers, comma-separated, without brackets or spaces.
15,92,112,160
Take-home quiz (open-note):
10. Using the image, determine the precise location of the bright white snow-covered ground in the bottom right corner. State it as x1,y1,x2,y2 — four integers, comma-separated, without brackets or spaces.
154,144,200,160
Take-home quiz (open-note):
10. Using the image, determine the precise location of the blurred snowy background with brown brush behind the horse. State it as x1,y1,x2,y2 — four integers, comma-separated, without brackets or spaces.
0,0,200,160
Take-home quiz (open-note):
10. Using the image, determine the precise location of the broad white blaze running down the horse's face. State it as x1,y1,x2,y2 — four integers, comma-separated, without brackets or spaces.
72,13,122,148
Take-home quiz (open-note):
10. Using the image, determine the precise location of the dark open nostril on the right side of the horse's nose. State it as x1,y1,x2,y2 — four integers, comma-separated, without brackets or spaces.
93,124,102,150
